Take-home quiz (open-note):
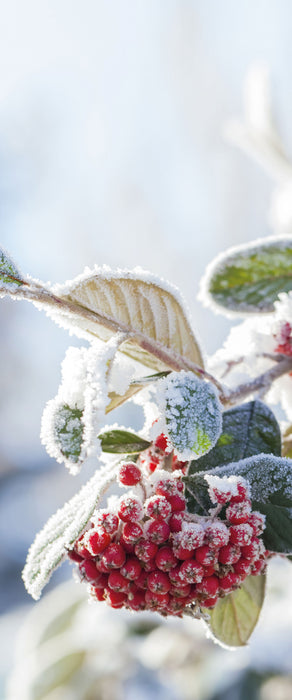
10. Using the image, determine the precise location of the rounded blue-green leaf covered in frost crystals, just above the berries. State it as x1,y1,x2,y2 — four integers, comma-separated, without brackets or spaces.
161,372,222,459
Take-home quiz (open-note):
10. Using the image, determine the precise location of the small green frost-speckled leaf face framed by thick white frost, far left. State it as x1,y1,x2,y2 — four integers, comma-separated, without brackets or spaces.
54,404,84,464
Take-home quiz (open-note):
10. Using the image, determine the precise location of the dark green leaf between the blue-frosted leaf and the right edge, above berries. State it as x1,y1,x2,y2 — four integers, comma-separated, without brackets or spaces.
189,401,281,474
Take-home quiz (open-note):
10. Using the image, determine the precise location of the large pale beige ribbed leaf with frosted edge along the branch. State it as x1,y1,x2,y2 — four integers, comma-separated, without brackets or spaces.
53,268,203,371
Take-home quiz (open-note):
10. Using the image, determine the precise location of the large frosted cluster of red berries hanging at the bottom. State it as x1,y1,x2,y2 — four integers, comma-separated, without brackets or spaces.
69,452,267,616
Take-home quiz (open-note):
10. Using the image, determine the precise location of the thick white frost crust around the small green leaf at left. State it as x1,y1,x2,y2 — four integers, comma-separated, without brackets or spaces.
41,336,125,474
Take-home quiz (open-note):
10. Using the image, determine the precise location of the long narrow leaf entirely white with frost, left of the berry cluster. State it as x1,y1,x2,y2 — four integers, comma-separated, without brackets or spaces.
22,466,116,600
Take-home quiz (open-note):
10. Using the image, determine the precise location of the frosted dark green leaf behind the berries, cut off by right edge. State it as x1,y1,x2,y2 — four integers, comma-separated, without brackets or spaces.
183,453,292,554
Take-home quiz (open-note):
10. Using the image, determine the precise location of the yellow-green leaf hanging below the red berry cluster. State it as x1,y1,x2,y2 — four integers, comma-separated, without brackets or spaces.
207,576,265,647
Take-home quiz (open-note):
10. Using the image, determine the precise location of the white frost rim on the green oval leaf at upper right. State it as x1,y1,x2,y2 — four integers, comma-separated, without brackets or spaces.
198,236,292,319
